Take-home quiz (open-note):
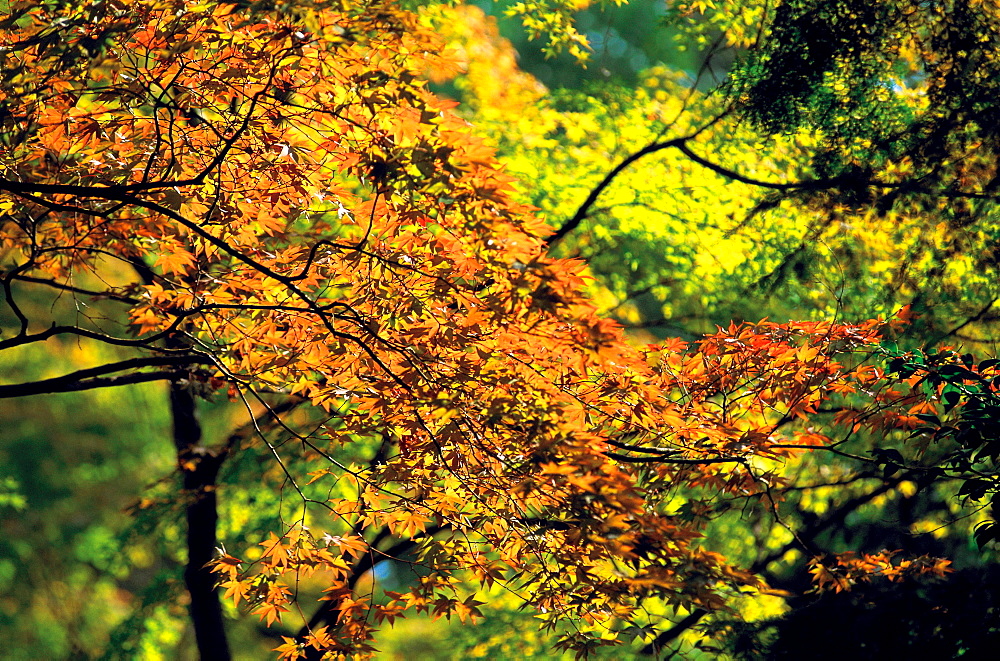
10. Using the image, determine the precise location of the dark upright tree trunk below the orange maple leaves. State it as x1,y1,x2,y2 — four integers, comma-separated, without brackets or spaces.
170,382,230,661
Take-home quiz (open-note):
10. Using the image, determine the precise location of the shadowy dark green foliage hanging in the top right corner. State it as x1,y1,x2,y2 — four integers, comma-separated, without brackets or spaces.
728,0,1000,174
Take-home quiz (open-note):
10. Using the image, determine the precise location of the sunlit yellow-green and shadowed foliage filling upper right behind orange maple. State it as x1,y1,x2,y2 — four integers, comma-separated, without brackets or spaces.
464,2,1000,348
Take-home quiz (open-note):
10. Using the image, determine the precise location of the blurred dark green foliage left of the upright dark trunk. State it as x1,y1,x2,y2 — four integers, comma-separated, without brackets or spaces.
0,388,177,660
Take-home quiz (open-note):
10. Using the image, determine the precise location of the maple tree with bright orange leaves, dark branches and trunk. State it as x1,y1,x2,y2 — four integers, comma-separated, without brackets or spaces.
0,0,998,659
